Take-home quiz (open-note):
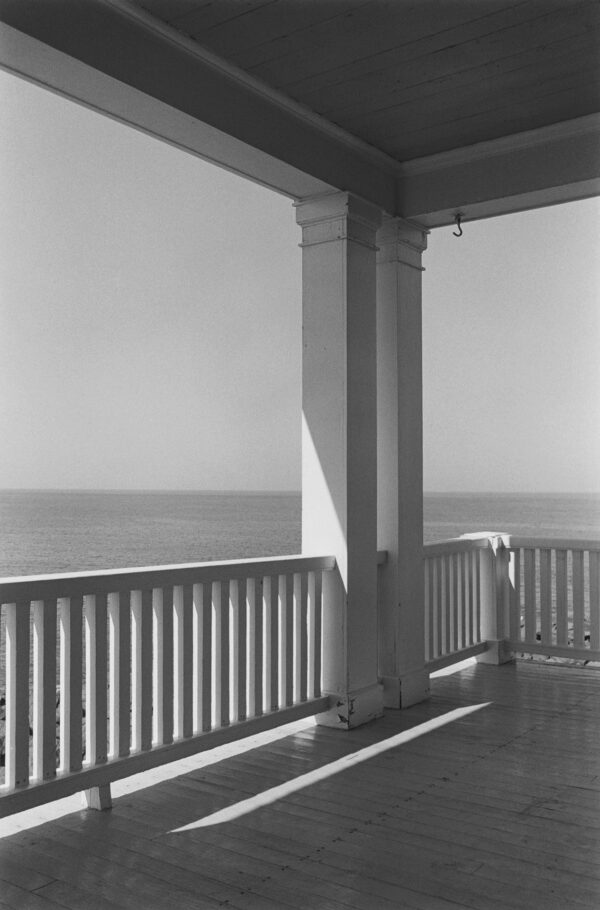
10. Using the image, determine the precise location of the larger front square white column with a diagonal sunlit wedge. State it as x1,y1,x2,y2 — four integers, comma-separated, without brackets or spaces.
296,193,382,729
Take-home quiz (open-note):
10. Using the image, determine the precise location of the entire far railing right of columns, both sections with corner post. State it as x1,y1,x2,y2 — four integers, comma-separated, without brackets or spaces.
424,534,600,670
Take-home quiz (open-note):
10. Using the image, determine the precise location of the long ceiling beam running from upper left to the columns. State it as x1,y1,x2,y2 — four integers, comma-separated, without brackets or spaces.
0,0,396,212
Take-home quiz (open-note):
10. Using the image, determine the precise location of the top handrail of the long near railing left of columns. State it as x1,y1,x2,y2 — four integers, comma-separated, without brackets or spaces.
0,556,335,603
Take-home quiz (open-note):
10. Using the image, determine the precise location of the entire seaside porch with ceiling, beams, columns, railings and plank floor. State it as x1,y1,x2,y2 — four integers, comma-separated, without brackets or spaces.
0,0,600,910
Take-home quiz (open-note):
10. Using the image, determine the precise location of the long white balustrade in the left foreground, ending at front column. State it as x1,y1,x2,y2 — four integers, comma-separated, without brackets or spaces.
0,557,335,815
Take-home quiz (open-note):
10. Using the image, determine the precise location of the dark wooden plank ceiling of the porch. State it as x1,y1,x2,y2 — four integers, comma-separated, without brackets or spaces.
135,0,600,161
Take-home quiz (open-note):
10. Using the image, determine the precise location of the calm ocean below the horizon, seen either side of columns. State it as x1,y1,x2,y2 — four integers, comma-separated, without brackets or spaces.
0,490,600,577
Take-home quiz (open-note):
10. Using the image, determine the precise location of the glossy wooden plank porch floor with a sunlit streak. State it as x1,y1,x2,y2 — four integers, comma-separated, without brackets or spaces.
0,663,600,910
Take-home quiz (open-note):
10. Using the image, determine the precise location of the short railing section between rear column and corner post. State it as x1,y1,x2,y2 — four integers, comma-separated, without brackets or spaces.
424,537,491,670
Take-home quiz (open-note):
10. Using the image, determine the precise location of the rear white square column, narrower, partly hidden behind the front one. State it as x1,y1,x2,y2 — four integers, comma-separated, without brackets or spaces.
377,218,429,708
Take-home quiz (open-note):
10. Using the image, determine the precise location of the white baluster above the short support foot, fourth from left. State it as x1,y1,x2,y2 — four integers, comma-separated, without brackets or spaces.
84,594,108,765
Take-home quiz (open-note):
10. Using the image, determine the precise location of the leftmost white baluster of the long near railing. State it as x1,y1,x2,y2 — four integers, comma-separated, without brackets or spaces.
5,601,30,789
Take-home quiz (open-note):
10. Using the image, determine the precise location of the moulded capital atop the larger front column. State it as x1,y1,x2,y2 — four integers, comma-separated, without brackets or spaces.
294,193,382,249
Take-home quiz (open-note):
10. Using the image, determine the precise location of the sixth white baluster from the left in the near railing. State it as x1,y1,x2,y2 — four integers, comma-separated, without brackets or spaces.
131,590,152,752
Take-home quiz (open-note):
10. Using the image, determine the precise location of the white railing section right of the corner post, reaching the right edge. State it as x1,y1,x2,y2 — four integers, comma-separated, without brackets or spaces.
502,535,600,661
